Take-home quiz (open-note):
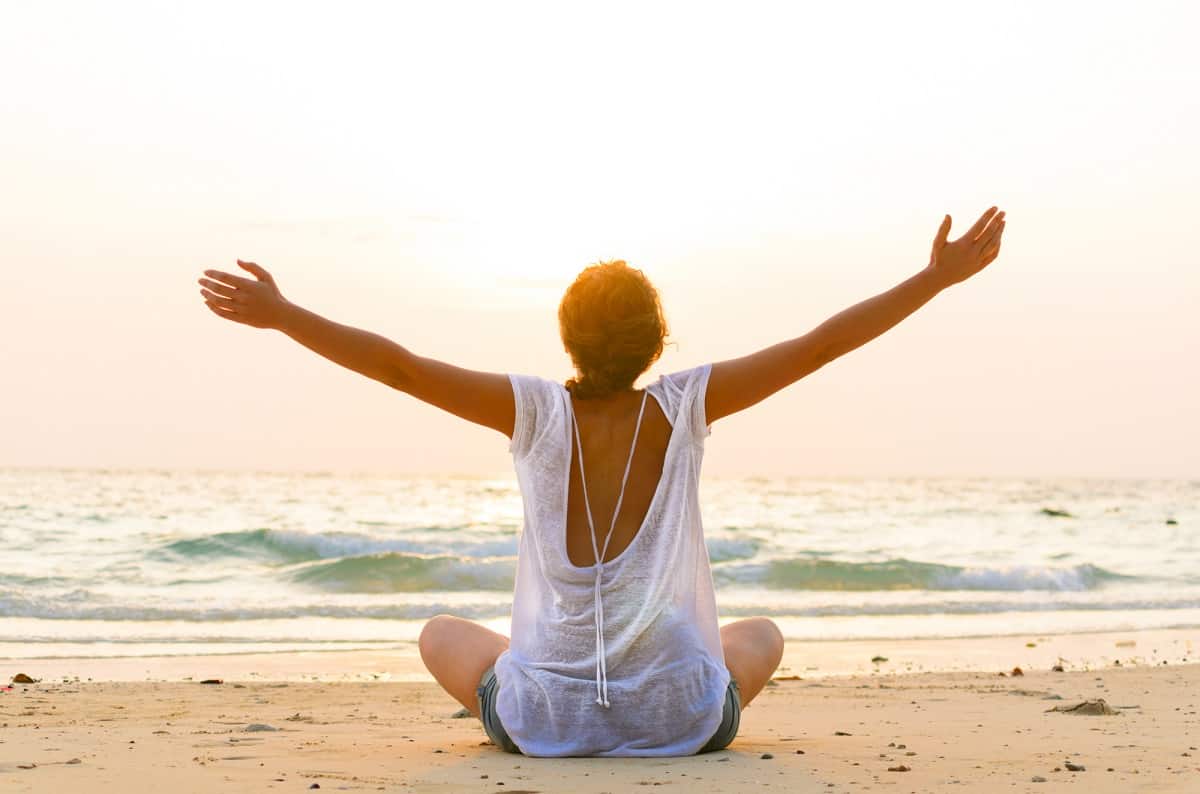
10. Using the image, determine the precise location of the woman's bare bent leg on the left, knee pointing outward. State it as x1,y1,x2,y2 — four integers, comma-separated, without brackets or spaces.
416,615,509,717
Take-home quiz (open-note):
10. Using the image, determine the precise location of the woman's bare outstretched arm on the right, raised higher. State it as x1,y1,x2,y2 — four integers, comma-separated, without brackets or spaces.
704,207,1004,422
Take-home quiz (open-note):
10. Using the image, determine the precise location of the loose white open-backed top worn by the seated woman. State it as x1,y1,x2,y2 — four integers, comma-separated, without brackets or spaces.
496,365,730,756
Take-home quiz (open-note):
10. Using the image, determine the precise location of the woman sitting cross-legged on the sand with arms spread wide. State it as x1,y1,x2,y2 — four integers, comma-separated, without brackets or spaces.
199,206,1004,756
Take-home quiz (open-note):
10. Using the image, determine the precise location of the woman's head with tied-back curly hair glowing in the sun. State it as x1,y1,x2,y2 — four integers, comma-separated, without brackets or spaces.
558,259,667,398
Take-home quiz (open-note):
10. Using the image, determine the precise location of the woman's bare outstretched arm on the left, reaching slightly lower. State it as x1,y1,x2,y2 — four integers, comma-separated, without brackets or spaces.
199,259,516,437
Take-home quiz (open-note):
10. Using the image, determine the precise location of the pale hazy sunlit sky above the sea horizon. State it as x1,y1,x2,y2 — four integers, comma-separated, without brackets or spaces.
0,0,1200,479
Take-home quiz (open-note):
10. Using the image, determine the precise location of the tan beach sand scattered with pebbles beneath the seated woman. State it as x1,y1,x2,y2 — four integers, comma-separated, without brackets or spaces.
0,630,1200,794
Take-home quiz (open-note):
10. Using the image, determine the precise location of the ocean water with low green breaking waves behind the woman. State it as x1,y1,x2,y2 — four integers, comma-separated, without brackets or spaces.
0,469,1200,658
